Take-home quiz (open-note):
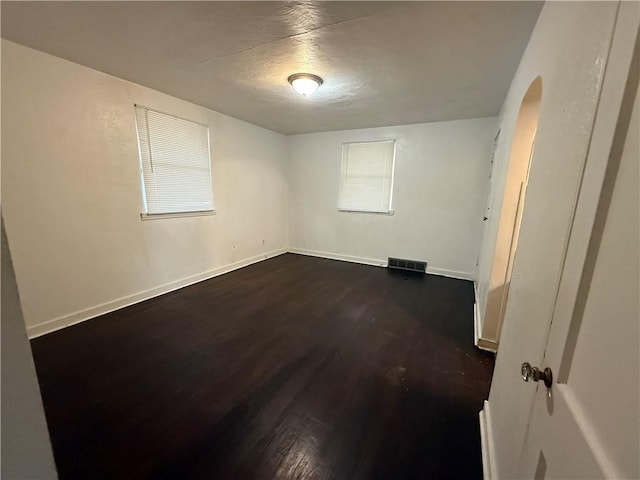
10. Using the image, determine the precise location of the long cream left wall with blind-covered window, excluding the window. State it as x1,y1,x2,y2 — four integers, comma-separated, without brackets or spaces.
2,40,288,335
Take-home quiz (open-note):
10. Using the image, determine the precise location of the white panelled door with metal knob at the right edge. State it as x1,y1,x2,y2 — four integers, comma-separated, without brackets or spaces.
514,6,640,479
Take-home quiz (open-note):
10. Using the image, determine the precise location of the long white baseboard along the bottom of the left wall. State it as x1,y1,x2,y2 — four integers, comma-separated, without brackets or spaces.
27,248,287,338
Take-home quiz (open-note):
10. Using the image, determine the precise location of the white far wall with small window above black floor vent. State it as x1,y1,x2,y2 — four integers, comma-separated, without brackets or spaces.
290,117,496,279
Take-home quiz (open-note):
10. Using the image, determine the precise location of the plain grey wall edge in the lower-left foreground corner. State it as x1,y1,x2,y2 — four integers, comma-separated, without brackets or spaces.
0,219,58,479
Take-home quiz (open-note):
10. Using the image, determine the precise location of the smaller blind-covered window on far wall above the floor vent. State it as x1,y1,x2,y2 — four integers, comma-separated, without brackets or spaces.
338,140,396,213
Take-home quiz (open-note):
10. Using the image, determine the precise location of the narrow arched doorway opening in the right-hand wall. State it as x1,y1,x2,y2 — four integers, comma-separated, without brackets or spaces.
484,77,542,341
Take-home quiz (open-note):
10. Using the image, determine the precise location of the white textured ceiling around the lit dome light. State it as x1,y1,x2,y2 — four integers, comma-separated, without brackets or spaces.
2,1,542,134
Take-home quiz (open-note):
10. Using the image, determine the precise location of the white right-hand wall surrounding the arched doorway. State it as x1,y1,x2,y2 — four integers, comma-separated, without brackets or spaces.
479,2,618,478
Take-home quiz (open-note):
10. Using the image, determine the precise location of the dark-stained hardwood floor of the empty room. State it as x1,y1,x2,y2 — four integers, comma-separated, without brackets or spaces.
31,254,493,480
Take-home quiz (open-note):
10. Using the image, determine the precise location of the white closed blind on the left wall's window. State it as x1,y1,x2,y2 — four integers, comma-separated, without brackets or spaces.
135,105,214,215
